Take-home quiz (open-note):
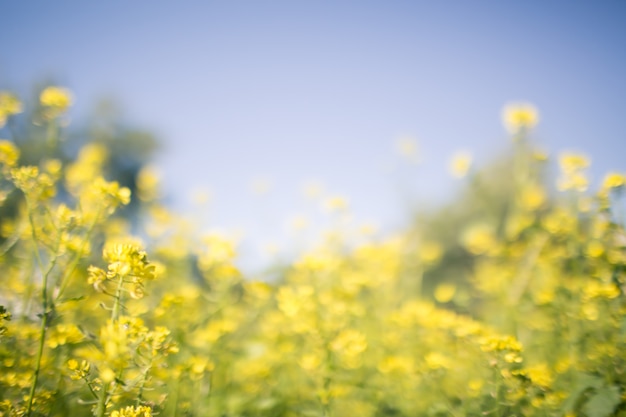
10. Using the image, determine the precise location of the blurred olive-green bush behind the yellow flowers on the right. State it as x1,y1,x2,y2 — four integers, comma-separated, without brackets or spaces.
408,138,552,308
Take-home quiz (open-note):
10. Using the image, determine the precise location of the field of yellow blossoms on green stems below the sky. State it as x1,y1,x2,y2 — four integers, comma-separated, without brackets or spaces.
0,87,626,417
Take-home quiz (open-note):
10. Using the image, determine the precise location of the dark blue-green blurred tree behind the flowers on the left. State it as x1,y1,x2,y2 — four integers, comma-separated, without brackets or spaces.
0,85,158,234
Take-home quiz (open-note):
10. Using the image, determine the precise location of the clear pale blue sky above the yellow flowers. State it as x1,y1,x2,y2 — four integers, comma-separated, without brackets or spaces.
0,0,626,270
